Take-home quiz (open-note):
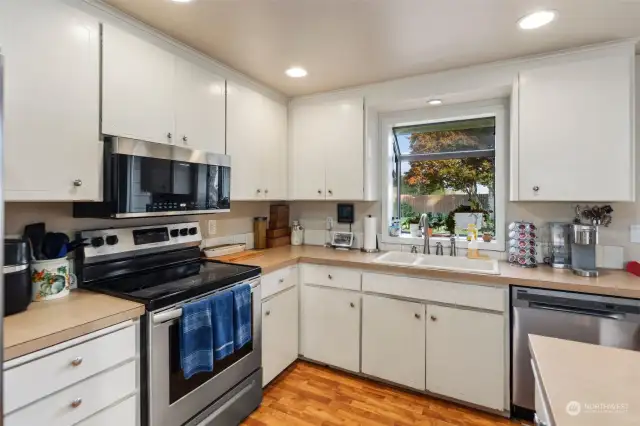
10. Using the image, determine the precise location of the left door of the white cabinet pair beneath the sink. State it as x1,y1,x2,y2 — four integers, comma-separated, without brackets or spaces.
362,295,426,390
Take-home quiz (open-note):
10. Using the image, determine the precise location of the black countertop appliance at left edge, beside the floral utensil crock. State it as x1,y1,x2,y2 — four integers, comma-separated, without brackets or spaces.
3,238,33,316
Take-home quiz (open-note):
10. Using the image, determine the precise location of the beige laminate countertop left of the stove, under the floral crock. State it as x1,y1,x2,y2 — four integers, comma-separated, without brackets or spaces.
3,290,144,361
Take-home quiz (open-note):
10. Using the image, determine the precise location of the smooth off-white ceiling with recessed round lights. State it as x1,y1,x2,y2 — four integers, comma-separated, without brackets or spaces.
105,0,640,96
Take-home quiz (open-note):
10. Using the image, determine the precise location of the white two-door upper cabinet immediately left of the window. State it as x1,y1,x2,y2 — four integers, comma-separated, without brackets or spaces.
289,98,364,200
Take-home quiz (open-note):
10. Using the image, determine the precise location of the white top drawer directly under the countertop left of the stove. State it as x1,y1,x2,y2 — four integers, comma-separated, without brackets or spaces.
4,319,136,413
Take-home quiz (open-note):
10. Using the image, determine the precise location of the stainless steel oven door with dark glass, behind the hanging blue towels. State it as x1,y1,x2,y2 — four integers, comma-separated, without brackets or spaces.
146,279,262,426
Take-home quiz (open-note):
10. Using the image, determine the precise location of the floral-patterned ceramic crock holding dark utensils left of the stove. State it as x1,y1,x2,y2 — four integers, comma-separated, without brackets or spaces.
31,258,77,302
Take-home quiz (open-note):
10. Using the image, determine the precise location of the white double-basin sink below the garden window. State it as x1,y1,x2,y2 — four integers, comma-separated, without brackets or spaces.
374,251,500,275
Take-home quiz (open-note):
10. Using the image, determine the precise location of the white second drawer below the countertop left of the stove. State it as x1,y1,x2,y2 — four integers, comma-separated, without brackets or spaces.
5,361,136,426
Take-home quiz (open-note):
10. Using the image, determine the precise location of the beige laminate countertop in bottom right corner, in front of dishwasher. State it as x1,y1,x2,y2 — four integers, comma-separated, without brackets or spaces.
529,335,640,426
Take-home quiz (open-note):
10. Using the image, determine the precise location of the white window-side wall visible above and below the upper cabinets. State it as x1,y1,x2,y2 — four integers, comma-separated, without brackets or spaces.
291,42,640,261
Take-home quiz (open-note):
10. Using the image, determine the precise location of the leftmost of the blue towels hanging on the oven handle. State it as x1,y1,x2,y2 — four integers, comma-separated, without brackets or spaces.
180,300,213,379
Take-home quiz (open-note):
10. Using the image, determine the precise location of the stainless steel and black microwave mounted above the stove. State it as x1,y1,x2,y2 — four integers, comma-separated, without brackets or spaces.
73,136,231,219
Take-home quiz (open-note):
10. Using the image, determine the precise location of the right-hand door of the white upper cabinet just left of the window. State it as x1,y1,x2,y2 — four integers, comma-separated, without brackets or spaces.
323,98,364,200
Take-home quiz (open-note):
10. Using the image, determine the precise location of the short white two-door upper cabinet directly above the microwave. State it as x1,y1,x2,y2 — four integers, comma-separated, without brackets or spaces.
102,25,226,154
